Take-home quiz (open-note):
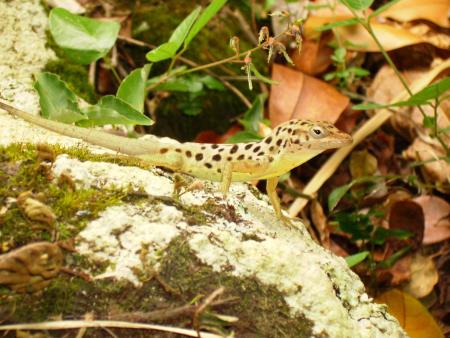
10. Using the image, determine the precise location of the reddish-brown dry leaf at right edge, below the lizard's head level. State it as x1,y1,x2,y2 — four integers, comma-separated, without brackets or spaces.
414,195,450,244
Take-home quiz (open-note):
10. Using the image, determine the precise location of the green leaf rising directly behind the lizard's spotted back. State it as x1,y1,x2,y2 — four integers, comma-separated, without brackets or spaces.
227,93,267,143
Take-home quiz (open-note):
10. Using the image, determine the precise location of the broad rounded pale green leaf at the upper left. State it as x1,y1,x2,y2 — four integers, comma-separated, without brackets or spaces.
49,8,120,64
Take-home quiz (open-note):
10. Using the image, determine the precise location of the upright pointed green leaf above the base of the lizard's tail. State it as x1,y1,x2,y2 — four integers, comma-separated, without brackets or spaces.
116,64,152,113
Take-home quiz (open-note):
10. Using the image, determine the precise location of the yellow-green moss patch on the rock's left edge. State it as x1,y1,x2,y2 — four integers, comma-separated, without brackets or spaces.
0,144,126,250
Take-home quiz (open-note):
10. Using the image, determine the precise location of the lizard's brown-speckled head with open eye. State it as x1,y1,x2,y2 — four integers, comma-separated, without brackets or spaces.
275,120,352,152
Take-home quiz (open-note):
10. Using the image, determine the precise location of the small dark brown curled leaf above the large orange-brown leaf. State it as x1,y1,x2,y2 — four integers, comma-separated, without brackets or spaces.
291,37,333,75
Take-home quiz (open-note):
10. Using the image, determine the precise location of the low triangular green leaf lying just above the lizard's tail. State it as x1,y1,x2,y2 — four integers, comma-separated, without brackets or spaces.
78,95,153,126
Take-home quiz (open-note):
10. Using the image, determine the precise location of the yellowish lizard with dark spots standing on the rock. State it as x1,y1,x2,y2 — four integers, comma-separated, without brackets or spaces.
0,101,352,219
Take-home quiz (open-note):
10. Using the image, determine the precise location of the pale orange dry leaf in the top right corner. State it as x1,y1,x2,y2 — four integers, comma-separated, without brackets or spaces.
380,0,450,27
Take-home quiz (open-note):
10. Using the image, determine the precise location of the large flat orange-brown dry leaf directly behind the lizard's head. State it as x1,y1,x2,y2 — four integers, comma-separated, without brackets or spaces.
269,64,349,127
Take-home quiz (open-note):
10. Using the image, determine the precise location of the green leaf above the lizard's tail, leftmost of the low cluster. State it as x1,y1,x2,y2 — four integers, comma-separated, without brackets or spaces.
34,72,86,123
